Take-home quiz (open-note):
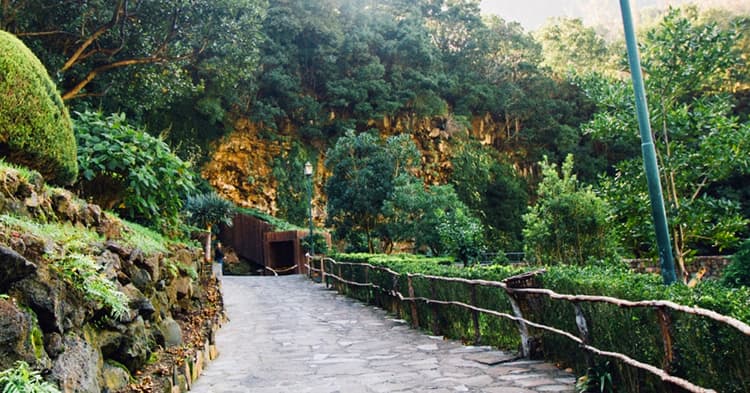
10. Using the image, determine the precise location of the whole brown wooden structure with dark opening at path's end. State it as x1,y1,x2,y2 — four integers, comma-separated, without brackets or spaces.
218,214,331,274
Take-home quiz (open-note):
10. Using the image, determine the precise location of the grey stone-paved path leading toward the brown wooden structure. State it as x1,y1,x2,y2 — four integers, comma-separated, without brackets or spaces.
192,275,575,393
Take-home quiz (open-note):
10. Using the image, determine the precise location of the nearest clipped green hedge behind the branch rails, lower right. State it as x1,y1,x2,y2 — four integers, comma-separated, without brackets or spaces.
530,266,750,392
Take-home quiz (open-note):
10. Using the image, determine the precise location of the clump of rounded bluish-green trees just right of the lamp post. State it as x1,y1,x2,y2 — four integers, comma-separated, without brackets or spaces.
326,131,484,254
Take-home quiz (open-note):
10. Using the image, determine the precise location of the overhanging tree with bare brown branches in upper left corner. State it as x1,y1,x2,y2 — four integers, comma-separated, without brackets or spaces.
0,0,265,110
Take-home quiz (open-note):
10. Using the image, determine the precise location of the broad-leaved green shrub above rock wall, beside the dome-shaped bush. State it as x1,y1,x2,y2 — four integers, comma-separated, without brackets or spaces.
75,112,196,234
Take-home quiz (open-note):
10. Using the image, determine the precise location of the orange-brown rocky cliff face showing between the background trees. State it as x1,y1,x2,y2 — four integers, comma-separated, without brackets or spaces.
202,116,496,217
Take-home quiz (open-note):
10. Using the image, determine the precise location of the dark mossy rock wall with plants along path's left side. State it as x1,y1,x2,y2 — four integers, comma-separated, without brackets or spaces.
0,165,212,393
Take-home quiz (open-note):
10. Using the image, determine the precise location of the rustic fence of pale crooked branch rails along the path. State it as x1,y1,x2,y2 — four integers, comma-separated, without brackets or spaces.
305,257,750,393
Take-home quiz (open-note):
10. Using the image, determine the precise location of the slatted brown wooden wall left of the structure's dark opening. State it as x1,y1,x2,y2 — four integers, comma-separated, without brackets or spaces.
219,214,273,265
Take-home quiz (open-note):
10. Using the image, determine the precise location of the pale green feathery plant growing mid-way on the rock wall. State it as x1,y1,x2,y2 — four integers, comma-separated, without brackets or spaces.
53,254,129,320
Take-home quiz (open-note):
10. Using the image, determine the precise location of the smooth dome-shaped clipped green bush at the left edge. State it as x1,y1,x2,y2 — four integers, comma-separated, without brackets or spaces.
0,31,78,184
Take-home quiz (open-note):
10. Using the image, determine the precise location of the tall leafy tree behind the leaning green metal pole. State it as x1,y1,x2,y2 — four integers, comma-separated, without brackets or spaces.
585,9,750,276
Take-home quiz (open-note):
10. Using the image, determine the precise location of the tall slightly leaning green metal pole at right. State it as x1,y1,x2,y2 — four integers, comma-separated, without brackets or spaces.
620,0,677,285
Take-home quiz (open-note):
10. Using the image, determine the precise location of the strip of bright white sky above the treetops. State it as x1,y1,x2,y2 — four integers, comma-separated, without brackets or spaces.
481,0,750,31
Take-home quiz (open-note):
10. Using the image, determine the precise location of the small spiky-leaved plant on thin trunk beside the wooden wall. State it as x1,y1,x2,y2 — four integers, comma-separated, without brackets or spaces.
184,192,237,262
